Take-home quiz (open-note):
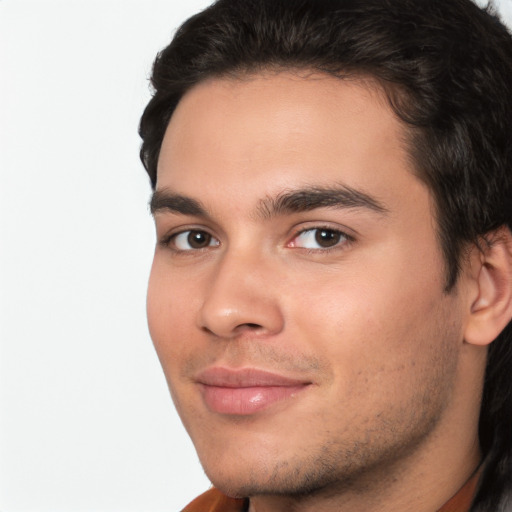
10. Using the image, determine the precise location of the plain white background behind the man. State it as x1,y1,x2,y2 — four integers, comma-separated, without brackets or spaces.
0,0,512,512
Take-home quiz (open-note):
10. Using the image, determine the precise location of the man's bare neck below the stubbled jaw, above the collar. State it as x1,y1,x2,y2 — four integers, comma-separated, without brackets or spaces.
249,352,481,512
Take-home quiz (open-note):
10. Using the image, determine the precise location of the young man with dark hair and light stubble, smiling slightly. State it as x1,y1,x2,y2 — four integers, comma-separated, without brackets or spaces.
140,0,512,512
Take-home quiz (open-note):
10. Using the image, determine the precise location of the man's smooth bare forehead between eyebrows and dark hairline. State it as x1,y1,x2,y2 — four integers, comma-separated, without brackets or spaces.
157,72,422,214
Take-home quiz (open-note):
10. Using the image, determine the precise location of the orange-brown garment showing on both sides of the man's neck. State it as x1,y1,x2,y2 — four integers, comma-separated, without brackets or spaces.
182,471,480,512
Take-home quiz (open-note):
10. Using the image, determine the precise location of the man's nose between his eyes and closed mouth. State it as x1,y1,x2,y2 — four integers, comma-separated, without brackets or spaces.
199,253,284,339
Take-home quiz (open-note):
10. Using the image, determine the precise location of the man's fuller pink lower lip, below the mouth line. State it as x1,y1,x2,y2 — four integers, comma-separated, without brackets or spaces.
202,385,307,415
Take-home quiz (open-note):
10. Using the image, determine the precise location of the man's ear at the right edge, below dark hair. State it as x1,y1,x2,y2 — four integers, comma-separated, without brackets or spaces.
464,227,512,346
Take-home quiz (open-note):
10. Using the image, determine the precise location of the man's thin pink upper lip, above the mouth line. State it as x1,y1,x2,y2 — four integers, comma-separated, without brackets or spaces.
196,367,311,388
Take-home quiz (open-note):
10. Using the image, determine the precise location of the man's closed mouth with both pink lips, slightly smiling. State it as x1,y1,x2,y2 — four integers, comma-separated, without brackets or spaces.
196,367,312,416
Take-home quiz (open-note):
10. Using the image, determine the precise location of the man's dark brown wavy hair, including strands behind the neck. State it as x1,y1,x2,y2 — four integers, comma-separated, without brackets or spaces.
140,0,512,512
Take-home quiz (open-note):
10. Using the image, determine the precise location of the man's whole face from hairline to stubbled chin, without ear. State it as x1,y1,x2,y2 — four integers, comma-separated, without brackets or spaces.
148,73,463,496
